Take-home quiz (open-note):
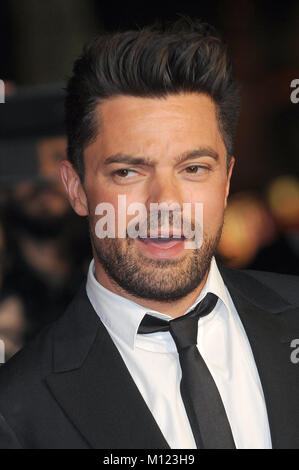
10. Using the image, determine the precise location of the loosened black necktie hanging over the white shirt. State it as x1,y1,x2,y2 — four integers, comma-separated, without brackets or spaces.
138,293,235,449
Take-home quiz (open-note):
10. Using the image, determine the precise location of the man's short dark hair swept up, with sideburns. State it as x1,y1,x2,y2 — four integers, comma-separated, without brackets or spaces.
65,17,240,181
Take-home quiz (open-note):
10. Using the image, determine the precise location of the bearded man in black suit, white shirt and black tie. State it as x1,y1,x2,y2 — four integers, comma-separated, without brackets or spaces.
0,21,299,449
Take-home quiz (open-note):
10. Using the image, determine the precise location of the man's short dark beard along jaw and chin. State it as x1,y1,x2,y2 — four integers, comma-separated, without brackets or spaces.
91,226,222,302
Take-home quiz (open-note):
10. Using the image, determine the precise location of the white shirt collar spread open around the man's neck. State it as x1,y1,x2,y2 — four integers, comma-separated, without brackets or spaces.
86,257,229,349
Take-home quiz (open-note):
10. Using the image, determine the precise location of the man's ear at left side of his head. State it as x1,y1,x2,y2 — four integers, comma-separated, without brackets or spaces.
59,160,88,216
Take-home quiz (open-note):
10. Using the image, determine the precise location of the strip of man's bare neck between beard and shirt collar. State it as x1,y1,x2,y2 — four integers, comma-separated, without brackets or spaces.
94,257,209,318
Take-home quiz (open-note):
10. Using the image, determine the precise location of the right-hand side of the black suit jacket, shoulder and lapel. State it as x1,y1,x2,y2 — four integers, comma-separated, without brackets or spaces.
220,267,299,448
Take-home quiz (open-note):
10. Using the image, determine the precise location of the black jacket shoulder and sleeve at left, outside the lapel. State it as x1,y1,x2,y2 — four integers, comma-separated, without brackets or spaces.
0,282,92,449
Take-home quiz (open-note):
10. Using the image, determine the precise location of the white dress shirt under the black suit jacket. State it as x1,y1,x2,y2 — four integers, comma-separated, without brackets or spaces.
86,258,272,449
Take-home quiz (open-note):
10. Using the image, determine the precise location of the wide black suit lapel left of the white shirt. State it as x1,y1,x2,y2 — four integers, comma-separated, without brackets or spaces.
47,284,169,449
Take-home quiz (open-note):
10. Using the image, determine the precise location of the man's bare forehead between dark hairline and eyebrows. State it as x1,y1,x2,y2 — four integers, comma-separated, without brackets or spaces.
87,93,225,162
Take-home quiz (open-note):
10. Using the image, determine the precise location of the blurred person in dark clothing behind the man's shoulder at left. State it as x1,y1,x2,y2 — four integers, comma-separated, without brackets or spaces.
4,181,76,336
